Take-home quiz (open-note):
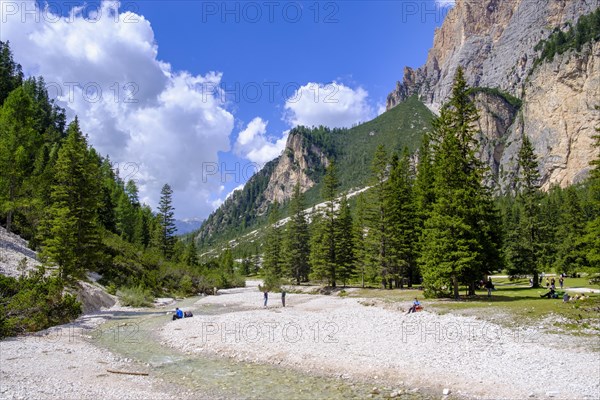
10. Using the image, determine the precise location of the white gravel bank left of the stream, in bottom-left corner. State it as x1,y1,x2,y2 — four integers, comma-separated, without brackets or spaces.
0,308,185,400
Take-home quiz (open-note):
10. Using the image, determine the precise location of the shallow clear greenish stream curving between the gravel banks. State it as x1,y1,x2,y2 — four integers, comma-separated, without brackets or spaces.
96,298,429,400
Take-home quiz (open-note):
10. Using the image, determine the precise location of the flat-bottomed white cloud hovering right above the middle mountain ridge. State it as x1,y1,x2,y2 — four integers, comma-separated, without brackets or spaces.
285,81,376,128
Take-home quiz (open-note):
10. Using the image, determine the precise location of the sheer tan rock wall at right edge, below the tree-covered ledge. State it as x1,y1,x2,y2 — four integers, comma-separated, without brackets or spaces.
501,42,600,189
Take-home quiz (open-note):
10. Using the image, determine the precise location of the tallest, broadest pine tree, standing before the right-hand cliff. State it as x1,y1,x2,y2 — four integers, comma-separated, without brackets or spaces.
420,68,498,298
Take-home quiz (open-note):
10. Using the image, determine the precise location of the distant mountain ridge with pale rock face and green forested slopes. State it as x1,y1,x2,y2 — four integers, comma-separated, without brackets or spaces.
195,97,434,249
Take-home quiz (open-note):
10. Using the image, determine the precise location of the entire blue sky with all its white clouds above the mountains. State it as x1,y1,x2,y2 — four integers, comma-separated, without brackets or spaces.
0,0,451,218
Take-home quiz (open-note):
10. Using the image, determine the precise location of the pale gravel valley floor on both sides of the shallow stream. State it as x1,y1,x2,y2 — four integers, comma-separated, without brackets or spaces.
0,282,600,400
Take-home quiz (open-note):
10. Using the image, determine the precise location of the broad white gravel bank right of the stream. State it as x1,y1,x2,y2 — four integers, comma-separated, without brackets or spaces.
161,287,600,400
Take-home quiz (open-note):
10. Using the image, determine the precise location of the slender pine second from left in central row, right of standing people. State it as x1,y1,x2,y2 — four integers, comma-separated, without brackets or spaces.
285,182,310,285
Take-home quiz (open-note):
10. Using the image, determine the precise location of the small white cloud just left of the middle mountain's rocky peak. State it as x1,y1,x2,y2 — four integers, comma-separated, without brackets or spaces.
233,117,288,166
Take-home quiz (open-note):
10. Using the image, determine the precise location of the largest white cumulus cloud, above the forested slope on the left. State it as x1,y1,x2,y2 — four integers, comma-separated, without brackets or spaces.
0,1,234,217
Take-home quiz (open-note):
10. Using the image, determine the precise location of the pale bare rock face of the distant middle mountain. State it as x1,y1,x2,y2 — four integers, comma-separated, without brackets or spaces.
265,133,329,204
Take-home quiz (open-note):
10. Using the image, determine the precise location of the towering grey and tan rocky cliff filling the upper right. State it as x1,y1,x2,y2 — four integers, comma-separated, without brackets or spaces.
387,0,600,188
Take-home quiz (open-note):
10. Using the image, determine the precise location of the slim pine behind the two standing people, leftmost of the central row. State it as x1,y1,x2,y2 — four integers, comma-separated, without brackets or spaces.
262,202,283,290
